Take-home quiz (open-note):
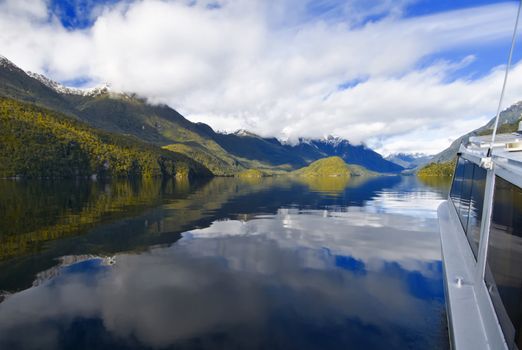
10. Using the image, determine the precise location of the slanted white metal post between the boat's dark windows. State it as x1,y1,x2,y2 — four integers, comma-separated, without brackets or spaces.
475,166,495,282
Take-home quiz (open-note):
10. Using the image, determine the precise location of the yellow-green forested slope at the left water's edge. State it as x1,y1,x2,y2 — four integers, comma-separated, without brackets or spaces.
0,97,210,177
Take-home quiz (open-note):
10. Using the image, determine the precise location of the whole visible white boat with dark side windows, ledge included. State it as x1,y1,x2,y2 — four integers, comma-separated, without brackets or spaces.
438,133,522,350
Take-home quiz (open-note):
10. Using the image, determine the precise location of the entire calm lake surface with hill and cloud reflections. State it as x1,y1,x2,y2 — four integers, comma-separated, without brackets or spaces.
0,177,449,349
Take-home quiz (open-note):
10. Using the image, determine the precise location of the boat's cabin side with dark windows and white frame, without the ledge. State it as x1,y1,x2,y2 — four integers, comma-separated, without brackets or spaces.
449,146,522,349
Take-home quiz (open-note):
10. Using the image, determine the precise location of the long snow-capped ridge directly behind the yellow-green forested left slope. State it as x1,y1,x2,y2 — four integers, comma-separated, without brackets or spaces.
0,57,247,175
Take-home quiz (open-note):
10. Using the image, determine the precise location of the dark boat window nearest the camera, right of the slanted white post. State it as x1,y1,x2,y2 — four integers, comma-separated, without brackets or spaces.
486,176,522,349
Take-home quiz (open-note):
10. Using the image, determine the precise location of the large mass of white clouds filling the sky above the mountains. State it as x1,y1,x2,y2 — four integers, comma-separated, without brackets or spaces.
0,0,522,153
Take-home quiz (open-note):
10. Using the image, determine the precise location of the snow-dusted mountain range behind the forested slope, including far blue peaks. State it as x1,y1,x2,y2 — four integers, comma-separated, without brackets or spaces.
0,56,404,179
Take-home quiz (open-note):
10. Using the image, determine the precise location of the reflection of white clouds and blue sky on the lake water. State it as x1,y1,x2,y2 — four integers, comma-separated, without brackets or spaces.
0,176,447,349
